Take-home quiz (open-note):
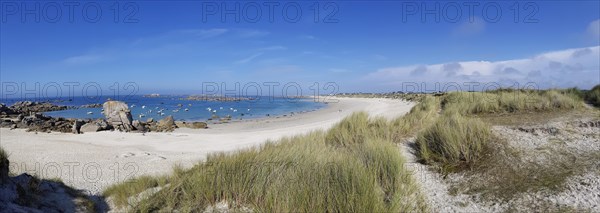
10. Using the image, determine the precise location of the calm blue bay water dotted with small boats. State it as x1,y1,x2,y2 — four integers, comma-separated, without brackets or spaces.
3,96,325,121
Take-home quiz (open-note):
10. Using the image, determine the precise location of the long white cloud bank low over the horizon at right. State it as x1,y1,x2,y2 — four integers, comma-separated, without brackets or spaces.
366,46,600,89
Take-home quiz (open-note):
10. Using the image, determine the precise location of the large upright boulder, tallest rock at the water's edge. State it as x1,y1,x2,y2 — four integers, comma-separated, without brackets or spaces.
102,101,135,132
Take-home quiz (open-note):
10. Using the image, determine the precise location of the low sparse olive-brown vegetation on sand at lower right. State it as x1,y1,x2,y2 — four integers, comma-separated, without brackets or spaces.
451,140,600,201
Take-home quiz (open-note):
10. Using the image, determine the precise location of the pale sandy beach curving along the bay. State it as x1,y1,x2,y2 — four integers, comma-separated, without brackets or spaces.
0,98,414,194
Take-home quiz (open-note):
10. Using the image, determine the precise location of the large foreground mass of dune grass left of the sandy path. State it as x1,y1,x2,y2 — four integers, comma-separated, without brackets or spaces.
105,113,426,212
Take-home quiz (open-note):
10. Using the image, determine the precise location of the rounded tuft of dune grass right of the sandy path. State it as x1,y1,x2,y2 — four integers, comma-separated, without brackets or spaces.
416,114,495,172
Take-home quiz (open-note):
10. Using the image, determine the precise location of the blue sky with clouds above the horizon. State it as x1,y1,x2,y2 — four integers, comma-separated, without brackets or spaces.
0,1,600,94
